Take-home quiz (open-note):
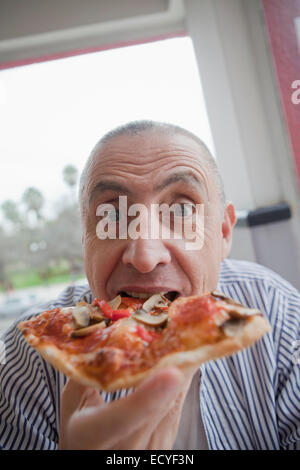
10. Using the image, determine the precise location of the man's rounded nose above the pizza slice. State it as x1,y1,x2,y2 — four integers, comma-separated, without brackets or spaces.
122,238,171,273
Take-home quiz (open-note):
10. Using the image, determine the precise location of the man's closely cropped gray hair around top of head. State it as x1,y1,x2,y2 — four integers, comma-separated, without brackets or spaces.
79,120,226,217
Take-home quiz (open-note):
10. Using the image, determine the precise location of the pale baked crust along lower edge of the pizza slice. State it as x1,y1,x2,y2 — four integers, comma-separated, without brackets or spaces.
20,315,270,392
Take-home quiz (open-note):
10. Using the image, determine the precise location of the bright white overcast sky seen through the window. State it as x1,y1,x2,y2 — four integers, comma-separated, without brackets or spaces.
0,38,214,218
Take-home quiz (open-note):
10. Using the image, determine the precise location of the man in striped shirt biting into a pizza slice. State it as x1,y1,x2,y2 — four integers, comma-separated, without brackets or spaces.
0,121,300,449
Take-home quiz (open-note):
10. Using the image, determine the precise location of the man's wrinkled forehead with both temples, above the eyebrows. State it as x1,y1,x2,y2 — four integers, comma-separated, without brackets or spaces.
82,131,220,213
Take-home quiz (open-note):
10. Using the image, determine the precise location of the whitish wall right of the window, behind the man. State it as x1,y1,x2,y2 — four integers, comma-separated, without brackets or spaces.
185,0,300,288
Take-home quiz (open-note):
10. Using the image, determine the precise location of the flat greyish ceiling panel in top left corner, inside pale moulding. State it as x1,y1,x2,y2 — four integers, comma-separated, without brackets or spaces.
0,0,169,40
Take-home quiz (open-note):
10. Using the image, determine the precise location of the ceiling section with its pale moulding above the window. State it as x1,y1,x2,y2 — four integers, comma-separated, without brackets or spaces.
0,0,185,64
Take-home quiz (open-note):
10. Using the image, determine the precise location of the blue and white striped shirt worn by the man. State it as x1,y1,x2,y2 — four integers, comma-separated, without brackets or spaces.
0,259,300,450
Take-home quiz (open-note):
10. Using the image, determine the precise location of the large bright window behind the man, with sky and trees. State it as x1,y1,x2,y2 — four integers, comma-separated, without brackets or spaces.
0,37,213,328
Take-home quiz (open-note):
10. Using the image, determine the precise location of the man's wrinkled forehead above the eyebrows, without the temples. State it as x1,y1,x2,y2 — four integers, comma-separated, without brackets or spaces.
88,131,211,191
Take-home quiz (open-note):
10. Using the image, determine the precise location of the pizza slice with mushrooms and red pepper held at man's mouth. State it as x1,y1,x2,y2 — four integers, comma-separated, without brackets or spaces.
19,292,270,391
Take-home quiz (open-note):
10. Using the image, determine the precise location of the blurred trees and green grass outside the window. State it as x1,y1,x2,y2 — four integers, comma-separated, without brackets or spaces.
0,165,84,290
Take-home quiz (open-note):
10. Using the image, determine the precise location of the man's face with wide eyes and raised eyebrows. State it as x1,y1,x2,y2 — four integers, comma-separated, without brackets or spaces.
83,132,235,300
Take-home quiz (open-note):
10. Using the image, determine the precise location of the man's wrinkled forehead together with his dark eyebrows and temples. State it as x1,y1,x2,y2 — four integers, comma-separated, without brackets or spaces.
81,130,223,218
